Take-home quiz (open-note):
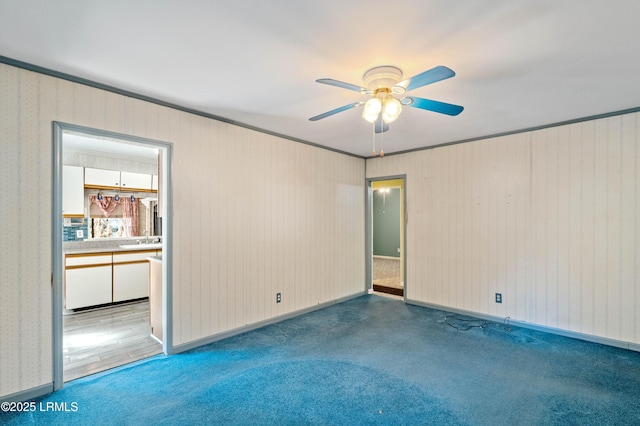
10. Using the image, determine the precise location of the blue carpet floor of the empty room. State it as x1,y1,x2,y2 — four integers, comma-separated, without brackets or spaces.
0,295,640,425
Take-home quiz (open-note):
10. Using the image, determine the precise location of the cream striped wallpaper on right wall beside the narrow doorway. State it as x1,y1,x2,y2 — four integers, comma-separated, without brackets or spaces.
366,113,640,347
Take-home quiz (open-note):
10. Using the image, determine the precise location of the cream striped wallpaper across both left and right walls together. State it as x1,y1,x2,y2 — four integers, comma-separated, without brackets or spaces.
0,59,640,397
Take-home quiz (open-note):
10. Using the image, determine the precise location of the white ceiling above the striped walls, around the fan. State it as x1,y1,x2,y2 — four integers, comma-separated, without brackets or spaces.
0,0,640,156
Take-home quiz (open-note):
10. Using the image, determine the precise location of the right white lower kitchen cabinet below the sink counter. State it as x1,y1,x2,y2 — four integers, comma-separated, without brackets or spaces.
113,250,155,302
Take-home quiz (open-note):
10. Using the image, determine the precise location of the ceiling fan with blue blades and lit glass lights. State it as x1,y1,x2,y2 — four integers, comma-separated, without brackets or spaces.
309,65,464,133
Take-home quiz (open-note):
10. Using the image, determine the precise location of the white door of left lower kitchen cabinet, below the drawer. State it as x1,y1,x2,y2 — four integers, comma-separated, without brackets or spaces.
65,265,111,309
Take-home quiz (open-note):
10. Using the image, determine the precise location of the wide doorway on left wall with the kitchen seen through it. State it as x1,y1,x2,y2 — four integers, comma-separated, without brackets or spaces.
53,123,172,389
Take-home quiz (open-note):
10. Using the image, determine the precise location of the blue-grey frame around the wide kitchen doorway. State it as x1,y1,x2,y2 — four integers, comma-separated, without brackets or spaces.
51,121,174,391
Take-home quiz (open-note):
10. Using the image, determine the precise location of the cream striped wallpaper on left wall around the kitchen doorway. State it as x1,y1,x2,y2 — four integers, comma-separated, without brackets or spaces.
0,64,365,397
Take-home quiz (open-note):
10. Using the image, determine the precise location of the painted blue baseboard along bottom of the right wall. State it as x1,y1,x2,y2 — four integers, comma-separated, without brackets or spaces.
406,300,640,352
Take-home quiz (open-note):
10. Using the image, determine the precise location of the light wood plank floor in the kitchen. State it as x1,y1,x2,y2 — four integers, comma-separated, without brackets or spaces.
63,300,162,382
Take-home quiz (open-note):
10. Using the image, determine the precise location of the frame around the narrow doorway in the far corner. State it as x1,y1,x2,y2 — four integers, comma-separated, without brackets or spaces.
365,174,408,302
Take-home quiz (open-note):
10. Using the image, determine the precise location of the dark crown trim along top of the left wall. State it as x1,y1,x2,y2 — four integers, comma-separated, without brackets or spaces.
0,55,366,159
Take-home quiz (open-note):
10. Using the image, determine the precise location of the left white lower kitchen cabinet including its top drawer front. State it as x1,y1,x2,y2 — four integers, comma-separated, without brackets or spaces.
65,253,112,309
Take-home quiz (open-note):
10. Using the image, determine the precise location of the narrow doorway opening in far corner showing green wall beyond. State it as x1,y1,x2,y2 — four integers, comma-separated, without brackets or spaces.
367,176,406,298
